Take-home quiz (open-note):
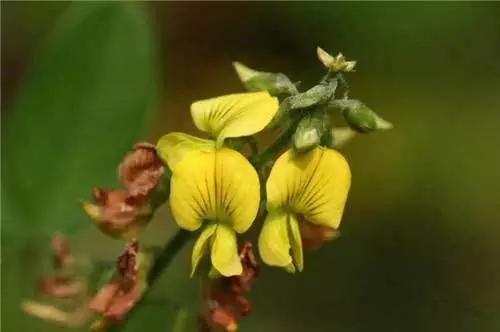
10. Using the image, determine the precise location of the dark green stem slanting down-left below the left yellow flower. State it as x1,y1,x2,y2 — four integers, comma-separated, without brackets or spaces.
108,229,192,332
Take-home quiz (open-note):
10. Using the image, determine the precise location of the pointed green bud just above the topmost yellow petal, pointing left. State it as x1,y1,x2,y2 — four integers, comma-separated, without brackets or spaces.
233,62,298,96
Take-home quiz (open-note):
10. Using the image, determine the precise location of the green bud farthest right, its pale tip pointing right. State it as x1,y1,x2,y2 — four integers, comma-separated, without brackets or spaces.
330,99,393,133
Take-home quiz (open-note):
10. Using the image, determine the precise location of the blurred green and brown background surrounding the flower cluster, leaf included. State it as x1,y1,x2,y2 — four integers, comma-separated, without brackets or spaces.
1,2,500,332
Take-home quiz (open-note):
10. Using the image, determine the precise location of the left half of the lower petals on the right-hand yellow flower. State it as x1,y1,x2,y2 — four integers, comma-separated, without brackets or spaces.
259,211,292,268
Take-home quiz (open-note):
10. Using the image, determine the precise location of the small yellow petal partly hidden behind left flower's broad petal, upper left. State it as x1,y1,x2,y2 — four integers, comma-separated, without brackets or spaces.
156,132,215,171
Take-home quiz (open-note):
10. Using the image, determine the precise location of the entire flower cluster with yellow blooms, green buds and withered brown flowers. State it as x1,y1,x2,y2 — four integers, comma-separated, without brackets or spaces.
25,48,392,331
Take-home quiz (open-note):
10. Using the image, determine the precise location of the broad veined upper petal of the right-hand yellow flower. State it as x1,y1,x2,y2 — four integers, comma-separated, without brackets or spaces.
266,147,351,228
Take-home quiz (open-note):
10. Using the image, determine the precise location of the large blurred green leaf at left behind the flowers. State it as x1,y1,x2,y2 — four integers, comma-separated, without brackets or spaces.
2,3,157,331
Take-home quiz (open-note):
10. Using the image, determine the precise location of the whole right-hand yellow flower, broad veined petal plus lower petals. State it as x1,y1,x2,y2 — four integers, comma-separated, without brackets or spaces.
259,147,351,272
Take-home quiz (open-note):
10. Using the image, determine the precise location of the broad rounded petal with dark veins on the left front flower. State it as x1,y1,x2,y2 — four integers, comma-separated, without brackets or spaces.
170,148,260,233
